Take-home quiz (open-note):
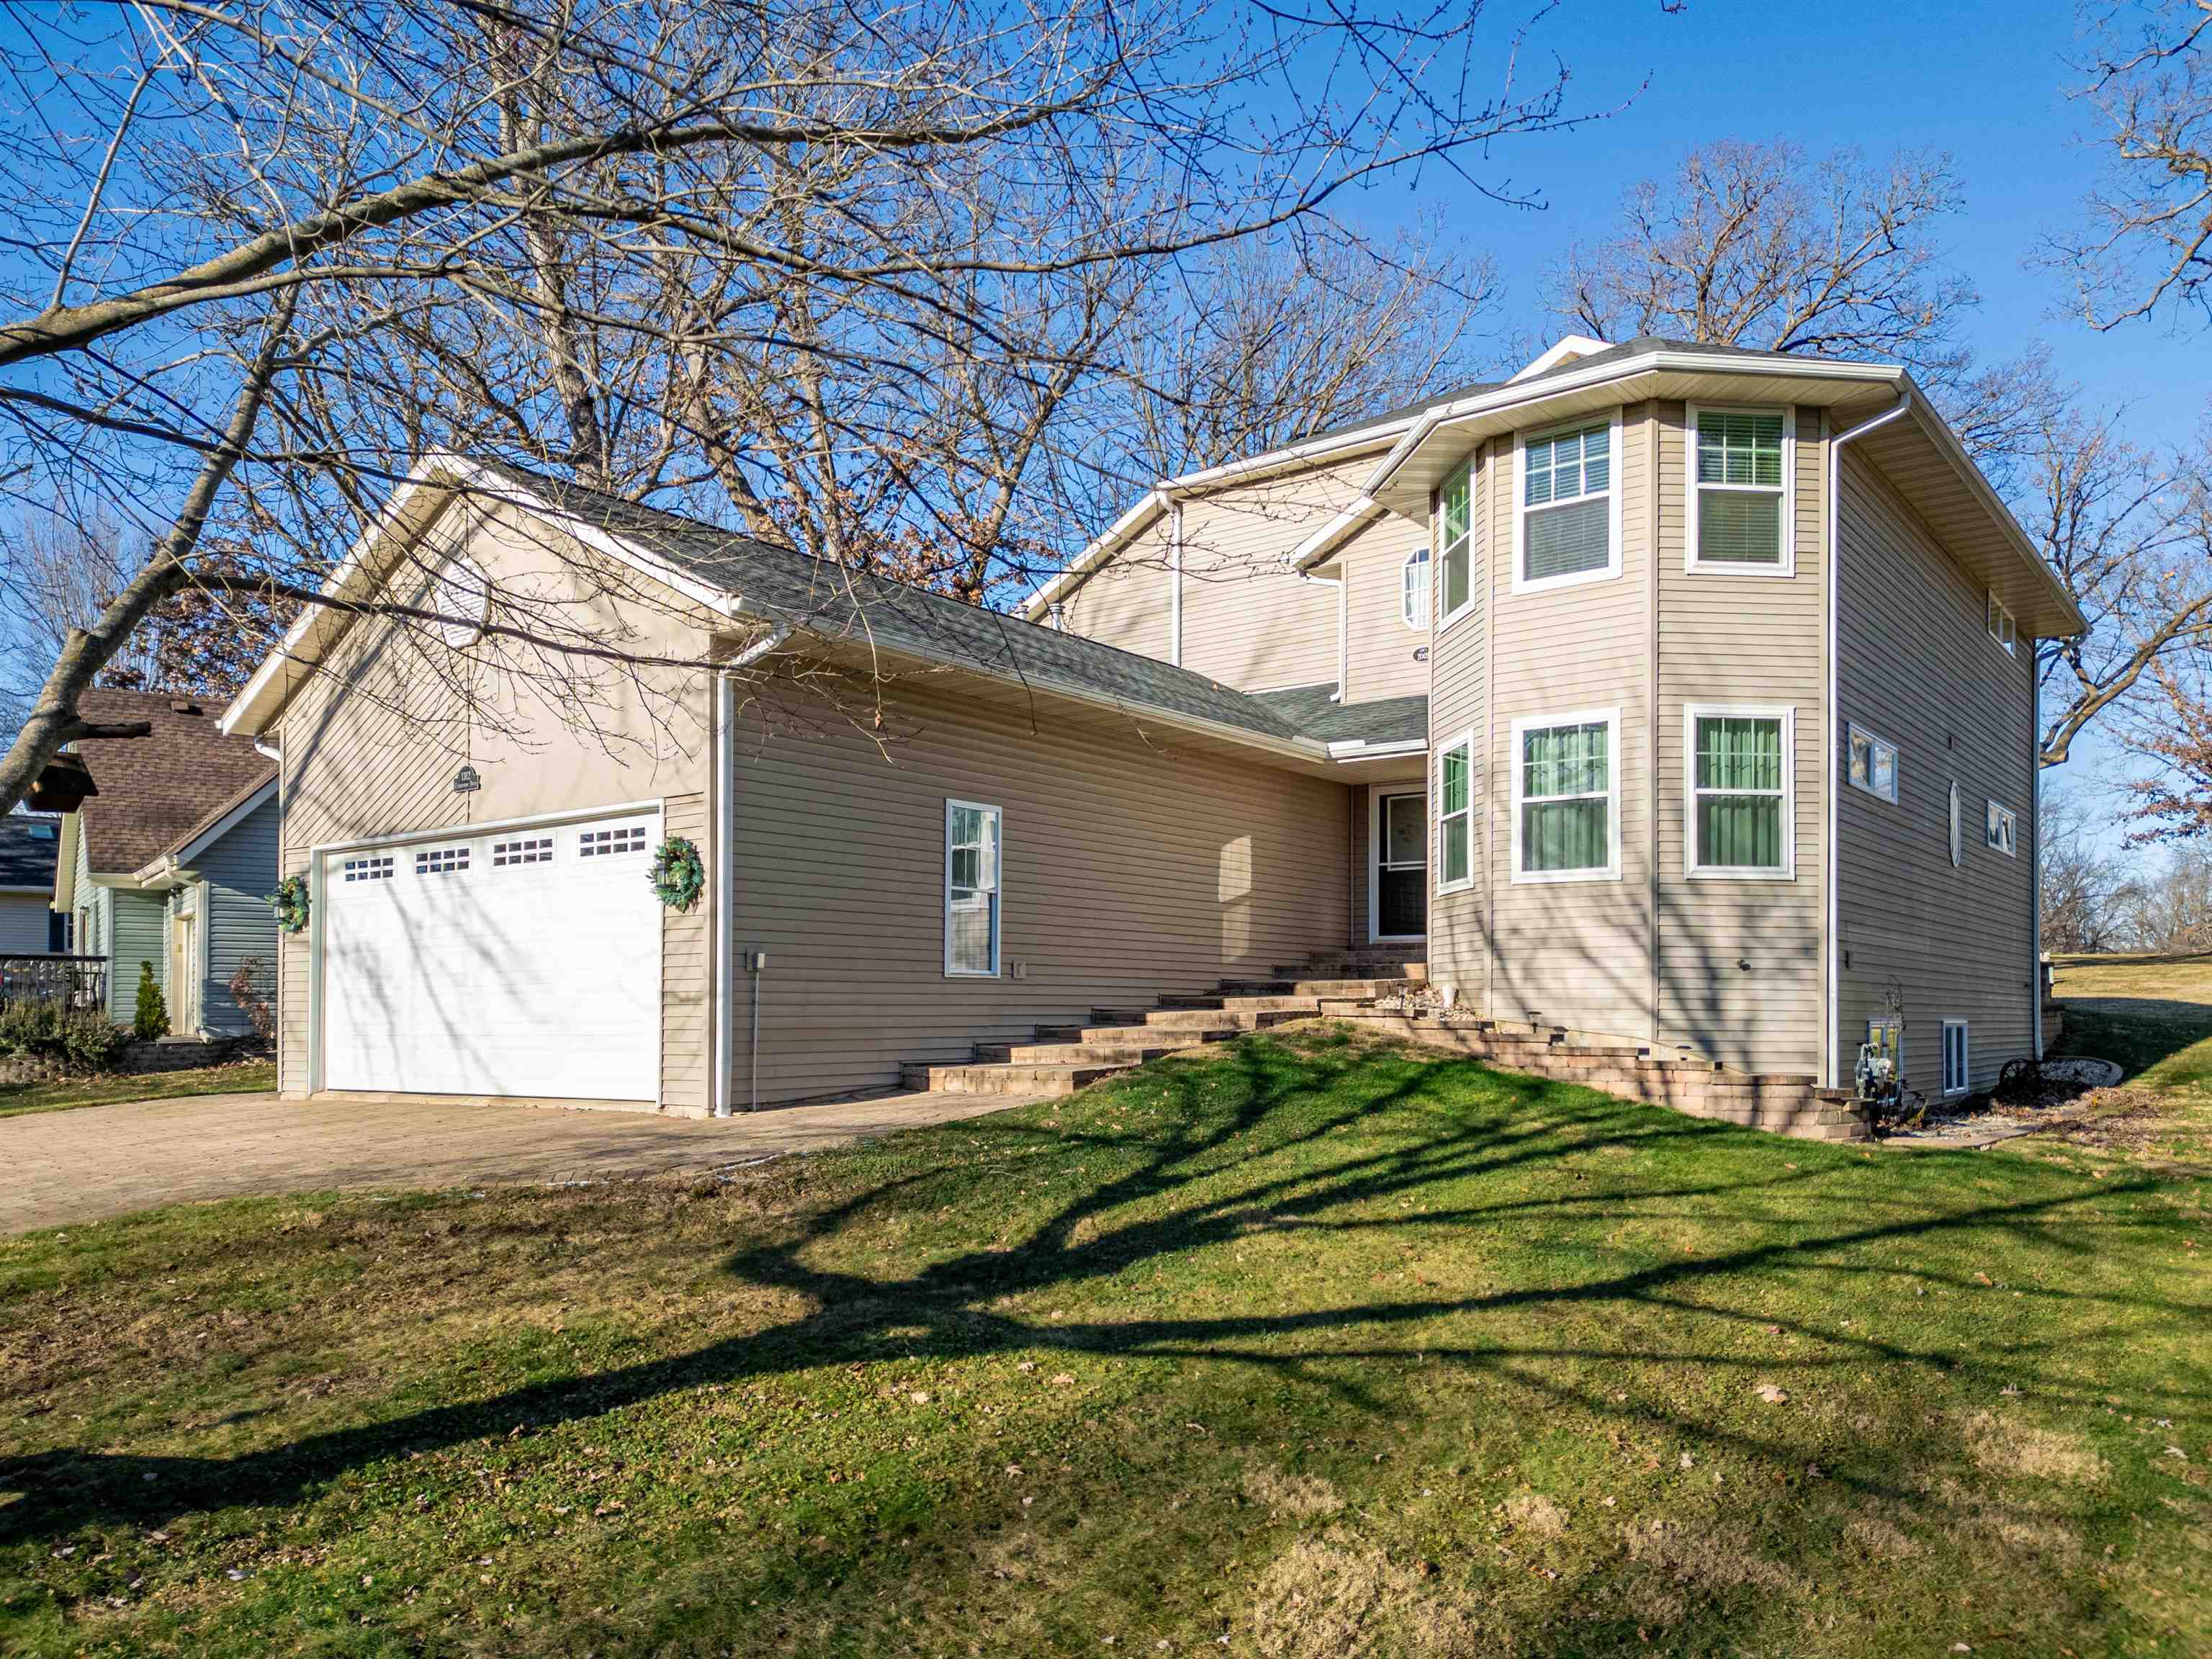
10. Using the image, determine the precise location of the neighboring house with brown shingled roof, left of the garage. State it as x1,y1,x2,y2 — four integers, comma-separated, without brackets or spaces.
33,690,276,1038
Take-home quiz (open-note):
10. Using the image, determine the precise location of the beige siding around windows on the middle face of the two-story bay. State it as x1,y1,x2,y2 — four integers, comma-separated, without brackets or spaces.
1484,411,1653,1035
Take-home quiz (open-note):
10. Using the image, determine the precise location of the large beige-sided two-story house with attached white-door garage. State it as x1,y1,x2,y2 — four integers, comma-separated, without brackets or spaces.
223,341,2082,1112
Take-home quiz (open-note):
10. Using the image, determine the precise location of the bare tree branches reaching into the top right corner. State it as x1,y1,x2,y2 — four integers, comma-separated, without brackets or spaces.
2046,0,2212,328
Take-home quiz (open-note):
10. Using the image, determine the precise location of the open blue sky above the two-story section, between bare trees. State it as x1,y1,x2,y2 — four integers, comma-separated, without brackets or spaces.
1398,0,2212,832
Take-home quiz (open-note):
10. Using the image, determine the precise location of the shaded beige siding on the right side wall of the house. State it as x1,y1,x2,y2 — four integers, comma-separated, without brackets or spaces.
1830,449,2037,1097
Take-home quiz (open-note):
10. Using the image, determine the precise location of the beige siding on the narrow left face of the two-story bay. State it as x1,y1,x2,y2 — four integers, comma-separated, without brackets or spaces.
1429,449,1498,1007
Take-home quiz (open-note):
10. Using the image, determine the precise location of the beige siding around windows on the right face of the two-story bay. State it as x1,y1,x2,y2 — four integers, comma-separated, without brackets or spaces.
1648,403,1827,1075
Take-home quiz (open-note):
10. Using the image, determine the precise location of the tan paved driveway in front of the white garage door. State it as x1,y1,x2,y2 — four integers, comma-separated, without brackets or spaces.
0,1095,1024,1232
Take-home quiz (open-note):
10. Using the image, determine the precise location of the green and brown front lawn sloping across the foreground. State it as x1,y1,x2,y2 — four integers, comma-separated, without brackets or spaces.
0,1035,2212,1659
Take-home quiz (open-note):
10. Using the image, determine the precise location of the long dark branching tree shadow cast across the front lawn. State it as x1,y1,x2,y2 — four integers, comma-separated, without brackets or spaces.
0,1040,2201,1544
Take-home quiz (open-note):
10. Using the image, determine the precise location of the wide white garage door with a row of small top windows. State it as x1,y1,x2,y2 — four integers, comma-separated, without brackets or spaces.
320,811,662,1100
